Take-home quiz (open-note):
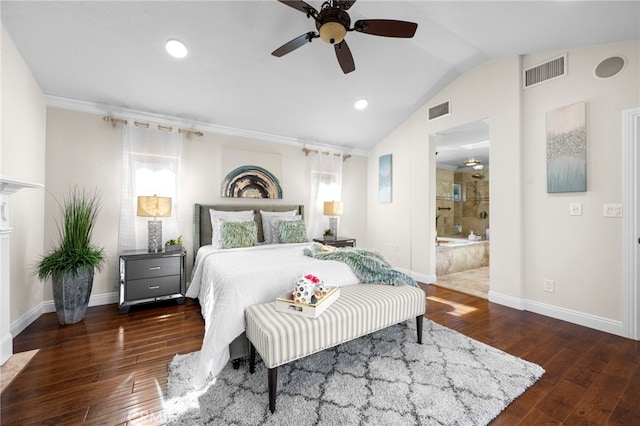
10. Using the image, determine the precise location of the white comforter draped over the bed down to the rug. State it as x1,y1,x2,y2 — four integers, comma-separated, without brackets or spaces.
187,243,359,386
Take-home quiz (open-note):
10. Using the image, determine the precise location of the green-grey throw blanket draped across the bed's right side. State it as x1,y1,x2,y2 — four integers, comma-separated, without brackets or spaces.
304,243,418,287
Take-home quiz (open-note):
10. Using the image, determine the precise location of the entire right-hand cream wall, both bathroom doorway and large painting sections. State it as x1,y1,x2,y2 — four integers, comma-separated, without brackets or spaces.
368,41,640,332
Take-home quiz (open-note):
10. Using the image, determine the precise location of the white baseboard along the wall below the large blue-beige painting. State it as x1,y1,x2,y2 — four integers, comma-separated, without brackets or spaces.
489,291,630,338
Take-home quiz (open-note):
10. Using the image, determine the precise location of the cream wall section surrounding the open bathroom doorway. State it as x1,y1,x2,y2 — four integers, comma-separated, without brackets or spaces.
368,57,522,290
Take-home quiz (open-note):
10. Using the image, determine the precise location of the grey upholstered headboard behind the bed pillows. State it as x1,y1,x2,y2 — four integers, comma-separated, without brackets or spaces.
193,204,304,253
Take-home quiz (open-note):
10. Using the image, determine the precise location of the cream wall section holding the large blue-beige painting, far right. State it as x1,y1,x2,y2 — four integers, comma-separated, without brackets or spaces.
522,41,640,321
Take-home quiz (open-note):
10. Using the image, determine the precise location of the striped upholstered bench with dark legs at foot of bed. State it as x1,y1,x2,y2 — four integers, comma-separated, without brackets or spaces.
245,284,426,413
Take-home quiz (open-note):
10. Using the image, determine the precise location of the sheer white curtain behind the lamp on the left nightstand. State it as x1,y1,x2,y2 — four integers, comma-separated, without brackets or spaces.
118,125,182,252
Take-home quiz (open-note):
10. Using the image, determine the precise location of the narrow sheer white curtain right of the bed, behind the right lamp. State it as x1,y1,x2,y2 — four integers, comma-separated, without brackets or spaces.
305,152,342,239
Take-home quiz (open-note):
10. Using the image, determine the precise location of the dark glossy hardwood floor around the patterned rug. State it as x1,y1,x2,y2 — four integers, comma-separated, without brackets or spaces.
0,285,640,425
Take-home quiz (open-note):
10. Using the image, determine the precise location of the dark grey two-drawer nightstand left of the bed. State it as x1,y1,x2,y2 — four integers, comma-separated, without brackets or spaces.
118,250,187,314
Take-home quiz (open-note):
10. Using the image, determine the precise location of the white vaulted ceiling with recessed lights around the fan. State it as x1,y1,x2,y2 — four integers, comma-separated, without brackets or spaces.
1,0,640,155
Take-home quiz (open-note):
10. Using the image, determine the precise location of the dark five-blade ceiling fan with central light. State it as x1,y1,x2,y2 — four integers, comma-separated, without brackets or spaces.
271,0,418,74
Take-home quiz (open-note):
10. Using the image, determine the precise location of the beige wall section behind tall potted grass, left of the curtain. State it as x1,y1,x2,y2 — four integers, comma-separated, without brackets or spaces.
44,108,122,304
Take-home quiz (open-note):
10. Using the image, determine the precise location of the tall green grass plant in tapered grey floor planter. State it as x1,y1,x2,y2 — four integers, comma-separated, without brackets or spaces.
37,188,105,325
